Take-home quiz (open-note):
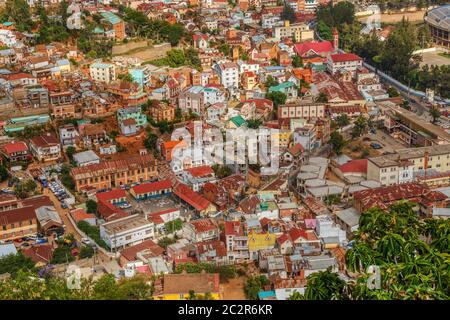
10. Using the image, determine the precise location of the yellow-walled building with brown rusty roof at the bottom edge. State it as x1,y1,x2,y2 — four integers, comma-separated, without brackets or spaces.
154,271,222,300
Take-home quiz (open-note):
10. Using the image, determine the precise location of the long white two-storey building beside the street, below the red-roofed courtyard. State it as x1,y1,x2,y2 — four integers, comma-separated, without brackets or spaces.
100,214,155,250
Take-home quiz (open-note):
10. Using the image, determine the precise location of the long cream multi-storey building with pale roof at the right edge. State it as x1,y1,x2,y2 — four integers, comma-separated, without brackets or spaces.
367,144,450,186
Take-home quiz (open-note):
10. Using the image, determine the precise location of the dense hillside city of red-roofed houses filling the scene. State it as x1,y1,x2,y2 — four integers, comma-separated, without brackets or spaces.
0,0,450,300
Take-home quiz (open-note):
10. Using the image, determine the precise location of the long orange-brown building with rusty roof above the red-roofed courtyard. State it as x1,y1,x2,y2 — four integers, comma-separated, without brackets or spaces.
71,155,158,191
